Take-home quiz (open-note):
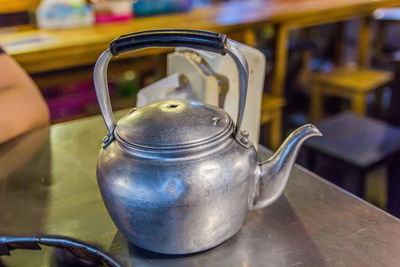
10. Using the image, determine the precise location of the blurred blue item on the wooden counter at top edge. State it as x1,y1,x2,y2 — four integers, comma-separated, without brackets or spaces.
133,0,193,17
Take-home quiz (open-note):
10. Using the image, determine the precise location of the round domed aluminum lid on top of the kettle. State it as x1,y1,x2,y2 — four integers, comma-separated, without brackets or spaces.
115,100,233,149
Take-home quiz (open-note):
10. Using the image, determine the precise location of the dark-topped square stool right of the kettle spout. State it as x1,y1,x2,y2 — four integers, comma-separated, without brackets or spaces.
305,113,400,205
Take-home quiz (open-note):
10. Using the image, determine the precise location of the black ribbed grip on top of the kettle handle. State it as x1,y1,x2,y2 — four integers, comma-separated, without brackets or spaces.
110,30,226,56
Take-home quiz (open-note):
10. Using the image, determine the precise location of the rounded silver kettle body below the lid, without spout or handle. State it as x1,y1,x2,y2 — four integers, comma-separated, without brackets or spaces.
97,136,257,254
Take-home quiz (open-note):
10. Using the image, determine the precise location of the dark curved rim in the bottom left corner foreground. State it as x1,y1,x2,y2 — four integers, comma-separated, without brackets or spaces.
0,236,121,267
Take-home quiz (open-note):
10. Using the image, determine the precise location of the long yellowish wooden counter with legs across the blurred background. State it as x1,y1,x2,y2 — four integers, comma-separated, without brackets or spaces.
0,0,398,89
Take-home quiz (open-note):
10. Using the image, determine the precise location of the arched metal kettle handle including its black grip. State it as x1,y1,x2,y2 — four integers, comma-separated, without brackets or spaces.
93,30,249,145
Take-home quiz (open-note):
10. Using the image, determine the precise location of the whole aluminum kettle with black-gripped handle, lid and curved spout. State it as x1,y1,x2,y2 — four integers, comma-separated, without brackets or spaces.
94,30,321,254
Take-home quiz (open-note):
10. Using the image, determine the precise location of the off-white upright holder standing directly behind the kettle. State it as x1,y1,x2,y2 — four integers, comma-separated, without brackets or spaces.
167,42,266,149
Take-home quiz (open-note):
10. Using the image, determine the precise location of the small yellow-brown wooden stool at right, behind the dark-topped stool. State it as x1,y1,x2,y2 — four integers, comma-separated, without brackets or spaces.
310,68,393,122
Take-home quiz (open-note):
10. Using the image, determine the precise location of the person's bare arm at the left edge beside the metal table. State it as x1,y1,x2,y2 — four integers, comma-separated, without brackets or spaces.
0,48,49,143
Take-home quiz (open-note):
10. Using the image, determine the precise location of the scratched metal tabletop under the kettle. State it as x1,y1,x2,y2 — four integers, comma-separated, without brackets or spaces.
0,111,400,266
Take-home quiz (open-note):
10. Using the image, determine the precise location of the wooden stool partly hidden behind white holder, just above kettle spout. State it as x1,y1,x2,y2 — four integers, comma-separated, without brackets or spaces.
260,93,286,150
